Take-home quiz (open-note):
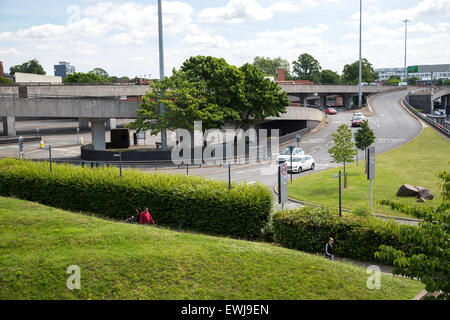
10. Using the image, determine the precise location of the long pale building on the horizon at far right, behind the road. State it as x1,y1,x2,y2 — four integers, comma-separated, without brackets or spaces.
375,64,450,83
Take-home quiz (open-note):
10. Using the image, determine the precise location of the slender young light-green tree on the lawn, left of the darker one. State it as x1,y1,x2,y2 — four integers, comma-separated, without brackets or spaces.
328,124,356,188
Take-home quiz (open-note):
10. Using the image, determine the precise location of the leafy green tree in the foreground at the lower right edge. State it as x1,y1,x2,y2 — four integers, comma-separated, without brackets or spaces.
375,171,450,300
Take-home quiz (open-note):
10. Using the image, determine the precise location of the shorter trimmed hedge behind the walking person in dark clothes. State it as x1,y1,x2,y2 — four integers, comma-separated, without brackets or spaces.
272,207,415,262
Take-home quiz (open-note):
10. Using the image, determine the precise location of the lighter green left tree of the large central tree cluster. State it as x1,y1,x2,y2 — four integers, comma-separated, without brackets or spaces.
128,69,227,135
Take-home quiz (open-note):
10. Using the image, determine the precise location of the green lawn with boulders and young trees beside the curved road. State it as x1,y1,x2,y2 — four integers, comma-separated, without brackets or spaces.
289,128,450,216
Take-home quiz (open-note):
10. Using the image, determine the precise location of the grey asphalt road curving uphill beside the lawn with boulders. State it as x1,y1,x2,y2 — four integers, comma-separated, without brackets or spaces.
178,91,422,188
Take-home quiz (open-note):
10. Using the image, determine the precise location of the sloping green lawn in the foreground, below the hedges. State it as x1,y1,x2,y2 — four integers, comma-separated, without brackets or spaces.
0,197,423,300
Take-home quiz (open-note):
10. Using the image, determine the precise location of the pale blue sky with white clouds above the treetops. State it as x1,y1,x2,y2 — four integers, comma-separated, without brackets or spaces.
0,0,450,78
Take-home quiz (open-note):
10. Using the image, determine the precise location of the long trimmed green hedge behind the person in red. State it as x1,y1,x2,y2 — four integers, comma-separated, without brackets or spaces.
0,159,273,239
